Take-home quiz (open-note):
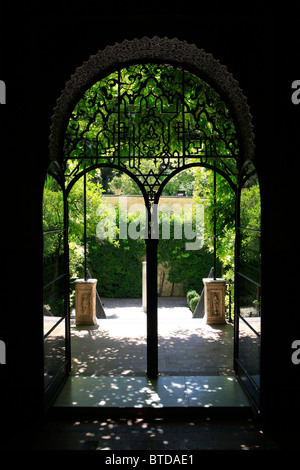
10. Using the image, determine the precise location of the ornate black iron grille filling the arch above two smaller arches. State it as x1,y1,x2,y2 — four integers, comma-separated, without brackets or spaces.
63,63,239,205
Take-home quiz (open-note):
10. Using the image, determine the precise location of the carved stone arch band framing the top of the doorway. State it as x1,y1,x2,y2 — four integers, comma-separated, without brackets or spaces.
49,37,255,165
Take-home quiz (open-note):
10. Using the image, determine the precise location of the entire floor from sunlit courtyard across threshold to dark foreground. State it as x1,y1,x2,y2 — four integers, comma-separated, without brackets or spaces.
29,298,291,450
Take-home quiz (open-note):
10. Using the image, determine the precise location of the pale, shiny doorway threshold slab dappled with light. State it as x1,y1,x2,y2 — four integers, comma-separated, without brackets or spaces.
52,376,251,414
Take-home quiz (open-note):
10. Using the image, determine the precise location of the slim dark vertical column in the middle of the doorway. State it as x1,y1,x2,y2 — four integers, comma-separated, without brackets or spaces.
146,206,158,379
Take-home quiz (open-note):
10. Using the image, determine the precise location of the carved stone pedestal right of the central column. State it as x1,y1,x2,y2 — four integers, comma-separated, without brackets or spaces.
203,278,226,325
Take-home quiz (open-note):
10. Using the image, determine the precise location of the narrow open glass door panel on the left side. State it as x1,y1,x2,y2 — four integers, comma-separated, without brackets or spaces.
43,164,69,407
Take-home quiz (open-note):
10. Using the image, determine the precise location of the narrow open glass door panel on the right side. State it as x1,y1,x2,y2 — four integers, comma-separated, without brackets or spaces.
235,164,261,409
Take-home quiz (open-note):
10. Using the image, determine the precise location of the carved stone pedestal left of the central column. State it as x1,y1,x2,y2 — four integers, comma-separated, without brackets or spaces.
75,279,97,326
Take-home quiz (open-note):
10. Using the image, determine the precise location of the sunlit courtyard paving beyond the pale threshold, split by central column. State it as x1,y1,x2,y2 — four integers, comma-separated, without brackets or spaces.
71,297,234,376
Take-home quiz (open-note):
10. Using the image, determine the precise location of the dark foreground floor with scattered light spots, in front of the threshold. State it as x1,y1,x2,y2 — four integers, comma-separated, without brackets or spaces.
32,417,276,452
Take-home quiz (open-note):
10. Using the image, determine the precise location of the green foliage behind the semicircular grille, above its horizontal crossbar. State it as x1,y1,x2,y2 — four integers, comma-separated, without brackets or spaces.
65,64,237,158
